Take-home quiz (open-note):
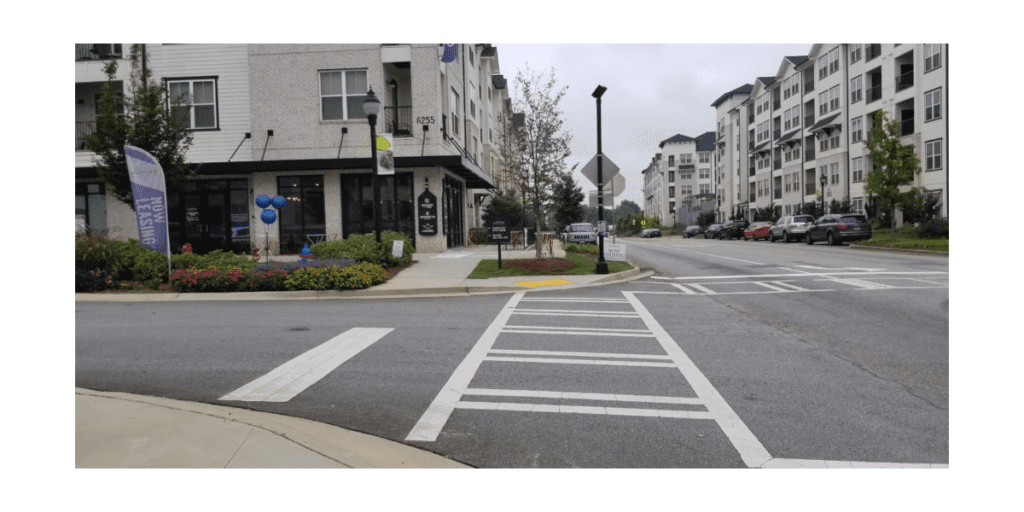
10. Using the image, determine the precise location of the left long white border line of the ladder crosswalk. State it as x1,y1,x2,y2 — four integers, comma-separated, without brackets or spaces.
406,292,524,442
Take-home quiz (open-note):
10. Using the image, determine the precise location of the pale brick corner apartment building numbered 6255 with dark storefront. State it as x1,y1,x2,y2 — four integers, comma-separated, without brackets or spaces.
76,44,508,254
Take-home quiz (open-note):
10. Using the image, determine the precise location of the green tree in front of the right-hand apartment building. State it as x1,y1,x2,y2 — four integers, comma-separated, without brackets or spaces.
864,110,921,232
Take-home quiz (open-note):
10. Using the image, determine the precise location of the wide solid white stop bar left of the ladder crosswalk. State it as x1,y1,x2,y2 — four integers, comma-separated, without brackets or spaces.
220,327,394,401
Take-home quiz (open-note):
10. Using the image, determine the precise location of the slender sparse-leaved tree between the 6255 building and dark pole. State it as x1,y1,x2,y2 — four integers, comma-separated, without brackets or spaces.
510,67,572,258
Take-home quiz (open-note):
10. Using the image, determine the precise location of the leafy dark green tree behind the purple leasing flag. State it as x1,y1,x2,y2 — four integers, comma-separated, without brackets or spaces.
85,44,193,209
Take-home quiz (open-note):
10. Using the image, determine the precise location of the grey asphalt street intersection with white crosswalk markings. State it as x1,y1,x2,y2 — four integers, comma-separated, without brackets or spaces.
75,237,949,468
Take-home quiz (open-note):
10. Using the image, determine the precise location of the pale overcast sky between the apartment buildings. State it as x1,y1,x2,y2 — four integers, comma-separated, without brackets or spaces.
493,42,811,207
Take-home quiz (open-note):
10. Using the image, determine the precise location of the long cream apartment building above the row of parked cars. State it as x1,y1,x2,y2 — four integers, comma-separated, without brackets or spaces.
696,44,948,226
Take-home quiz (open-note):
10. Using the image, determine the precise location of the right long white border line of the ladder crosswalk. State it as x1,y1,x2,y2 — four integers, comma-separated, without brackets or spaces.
623,292,771,468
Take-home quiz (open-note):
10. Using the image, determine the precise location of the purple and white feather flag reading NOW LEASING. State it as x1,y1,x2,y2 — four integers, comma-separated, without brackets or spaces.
125,145,171,258
